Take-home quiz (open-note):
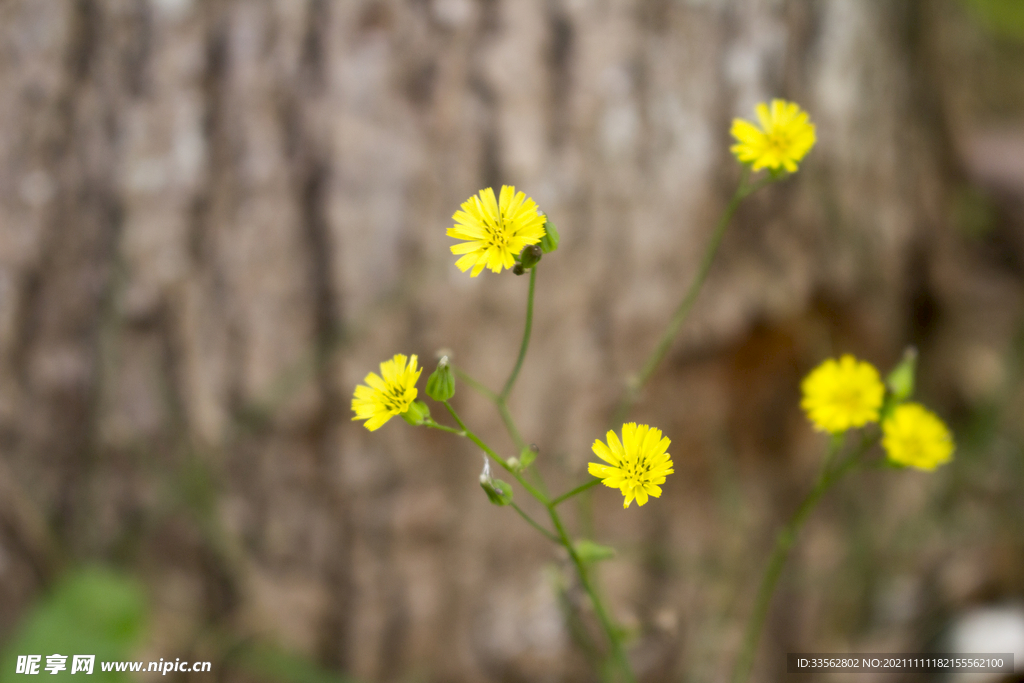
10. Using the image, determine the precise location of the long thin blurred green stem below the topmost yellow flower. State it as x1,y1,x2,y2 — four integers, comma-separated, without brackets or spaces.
610,167,775,427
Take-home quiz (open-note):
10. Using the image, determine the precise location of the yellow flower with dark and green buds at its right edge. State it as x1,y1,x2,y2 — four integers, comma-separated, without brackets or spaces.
445,185,545,278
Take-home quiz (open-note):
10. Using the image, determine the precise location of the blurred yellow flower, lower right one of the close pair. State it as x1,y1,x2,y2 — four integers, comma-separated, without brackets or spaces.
882,403,956,470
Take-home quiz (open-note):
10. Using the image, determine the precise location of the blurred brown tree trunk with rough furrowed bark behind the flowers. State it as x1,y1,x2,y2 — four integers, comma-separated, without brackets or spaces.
0,0,1024,681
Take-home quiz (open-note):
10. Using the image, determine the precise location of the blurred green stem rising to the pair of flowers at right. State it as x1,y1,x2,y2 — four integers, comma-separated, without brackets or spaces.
732,434,878,683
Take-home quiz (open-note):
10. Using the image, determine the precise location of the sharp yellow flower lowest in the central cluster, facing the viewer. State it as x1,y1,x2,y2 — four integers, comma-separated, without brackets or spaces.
587,422,675,508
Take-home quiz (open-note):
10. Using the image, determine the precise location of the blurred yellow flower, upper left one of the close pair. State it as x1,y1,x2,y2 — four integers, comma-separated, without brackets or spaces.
800,355,886,434
